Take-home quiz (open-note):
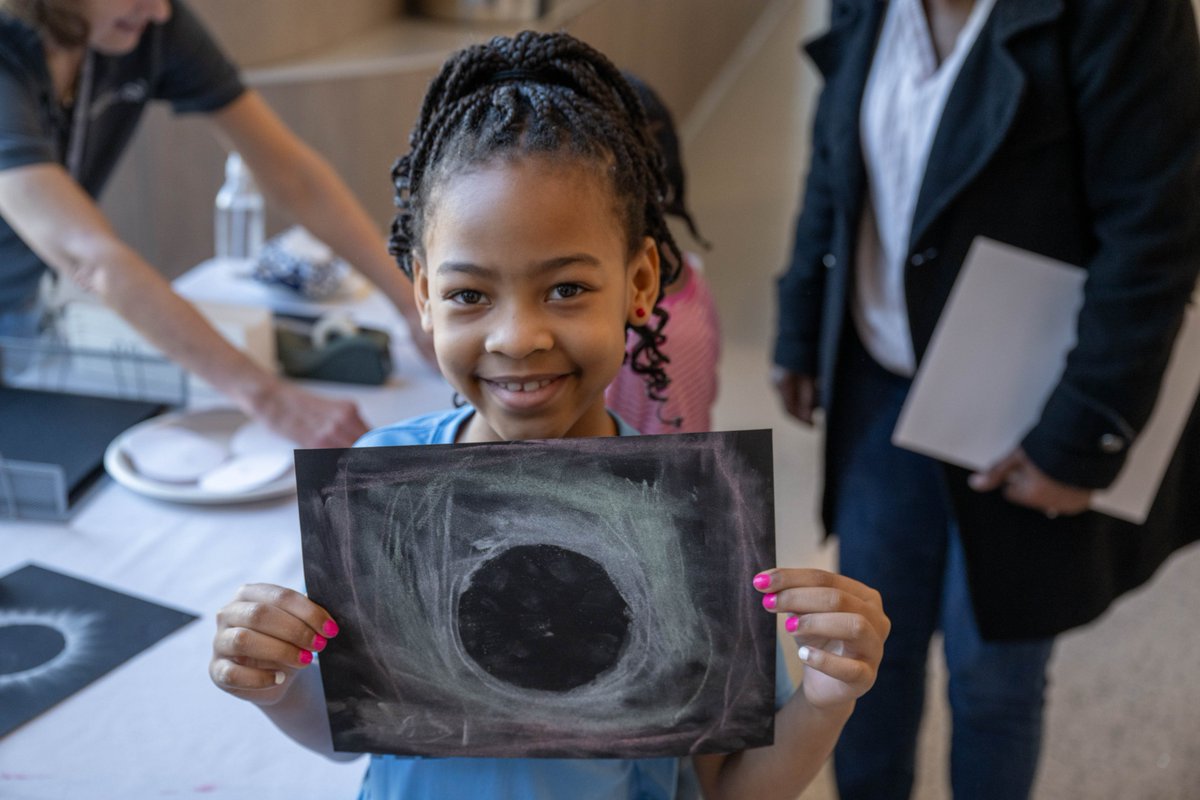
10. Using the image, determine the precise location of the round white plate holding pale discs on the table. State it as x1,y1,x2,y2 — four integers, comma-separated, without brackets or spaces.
104,409,296,505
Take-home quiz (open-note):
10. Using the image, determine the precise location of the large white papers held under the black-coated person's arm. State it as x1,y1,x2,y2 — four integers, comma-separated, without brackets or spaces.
892,239,1200,524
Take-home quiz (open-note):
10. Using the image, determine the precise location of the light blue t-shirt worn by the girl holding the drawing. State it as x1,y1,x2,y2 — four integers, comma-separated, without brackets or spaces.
356,405,793,800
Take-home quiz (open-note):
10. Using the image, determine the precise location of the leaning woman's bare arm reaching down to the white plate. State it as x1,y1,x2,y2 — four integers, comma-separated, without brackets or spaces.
0,163,366,447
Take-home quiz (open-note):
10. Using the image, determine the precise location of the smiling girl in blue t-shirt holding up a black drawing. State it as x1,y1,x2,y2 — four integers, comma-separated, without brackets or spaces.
209,32,888,800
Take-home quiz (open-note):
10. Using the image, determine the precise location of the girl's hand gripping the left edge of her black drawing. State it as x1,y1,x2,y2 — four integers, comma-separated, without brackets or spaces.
209,583,337,705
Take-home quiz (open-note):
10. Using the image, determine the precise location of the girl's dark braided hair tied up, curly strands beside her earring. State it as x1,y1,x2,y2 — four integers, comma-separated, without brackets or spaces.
390,31,683,401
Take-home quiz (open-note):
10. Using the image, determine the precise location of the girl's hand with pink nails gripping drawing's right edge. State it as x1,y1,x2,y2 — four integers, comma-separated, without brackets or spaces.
754,569,892,709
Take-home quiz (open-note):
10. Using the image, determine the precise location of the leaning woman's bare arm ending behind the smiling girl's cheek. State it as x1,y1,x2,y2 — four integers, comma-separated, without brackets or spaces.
212,90,432,360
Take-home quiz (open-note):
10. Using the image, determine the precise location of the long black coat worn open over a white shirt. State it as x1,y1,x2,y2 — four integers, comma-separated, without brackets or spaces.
775,0,1200,638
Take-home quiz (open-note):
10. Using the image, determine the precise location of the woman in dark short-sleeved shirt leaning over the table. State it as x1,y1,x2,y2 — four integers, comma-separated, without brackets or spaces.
0,0,425,446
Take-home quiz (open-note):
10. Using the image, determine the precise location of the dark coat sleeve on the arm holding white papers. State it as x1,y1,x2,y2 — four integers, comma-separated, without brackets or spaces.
1021,0,1200,488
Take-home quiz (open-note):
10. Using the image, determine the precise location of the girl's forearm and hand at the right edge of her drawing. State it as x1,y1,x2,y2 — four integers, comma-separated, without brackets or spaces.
694,570,892,800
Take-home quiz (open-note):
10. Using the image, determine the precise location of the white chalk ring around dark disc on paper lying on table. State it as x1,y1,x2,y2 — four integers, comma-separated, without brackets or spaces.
0,609,101,690
